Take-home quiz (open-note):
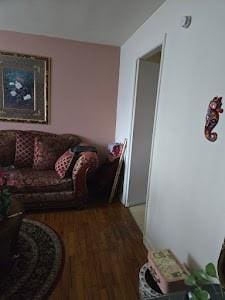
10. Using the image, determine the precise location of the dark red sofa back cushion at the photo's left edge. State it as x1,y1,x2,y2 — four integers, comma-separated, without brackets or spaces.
0,133,16,166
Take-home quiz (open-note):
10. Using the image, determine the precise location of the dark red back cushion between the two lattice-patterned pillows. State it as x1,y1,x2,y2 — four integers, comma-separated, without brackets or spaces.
33,136,71,170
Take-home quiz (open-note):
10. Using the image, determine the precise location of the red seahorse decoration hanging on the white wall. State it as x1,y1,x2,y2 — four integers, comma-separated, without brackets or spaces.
205,97,223,142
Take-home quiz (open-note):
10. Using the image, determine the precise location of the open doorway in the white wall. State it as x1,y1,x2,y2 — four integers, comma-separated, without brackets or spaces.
127,46,162,232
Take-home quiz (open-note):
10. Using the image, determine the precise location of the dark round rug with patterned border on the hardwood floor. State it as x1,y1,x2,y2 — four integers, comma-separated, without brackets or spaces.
0,219,64,300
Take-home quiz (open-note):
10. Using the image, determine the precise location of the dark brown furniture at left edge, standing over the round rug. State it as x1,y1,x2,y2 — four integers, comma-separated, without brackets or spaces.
0,200,24,278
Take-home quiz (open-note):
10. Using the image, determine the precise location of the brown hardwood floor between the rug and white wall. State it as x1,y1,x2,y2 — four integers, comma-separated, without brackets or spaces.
27,203,147,300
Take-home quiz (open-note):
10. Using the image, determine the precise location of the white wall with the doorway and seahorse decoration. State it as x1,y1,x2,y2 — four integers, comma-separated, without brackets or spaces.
116,0,225,264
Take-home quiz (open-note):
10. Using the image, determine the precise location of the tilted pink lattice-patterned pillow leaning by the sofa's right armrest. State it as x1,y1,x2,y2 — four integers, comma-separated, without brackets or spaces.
55,150,75,178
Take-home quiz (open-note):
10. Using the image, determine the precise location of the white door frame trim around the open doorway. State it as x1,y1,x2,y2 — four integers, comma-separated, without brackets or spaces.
123,34,167,214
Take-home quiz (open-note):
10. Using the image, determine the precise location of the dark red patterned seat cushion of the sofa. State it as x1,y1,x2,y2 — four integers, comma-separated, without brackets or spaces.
7,168,73,193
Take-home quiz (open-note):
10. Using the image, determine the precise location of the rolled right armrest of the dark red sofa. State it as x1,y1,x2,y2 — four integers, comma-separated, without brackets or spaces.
72,152,98,198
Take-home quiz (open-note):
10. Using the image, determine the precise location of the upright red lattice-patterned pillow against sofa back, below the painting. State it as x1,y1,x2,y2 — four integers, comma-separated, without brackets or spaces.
14,131,34,168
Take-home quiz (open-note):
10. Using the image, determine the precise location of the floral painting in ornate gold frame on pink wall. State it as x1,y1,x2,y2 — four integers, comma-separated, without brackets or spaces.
0,51,50,124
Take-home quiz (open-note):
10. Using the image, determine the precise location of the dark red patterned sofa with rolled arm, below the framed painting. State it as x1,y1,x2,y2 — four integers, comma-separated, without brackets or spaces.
0,130,98,210
